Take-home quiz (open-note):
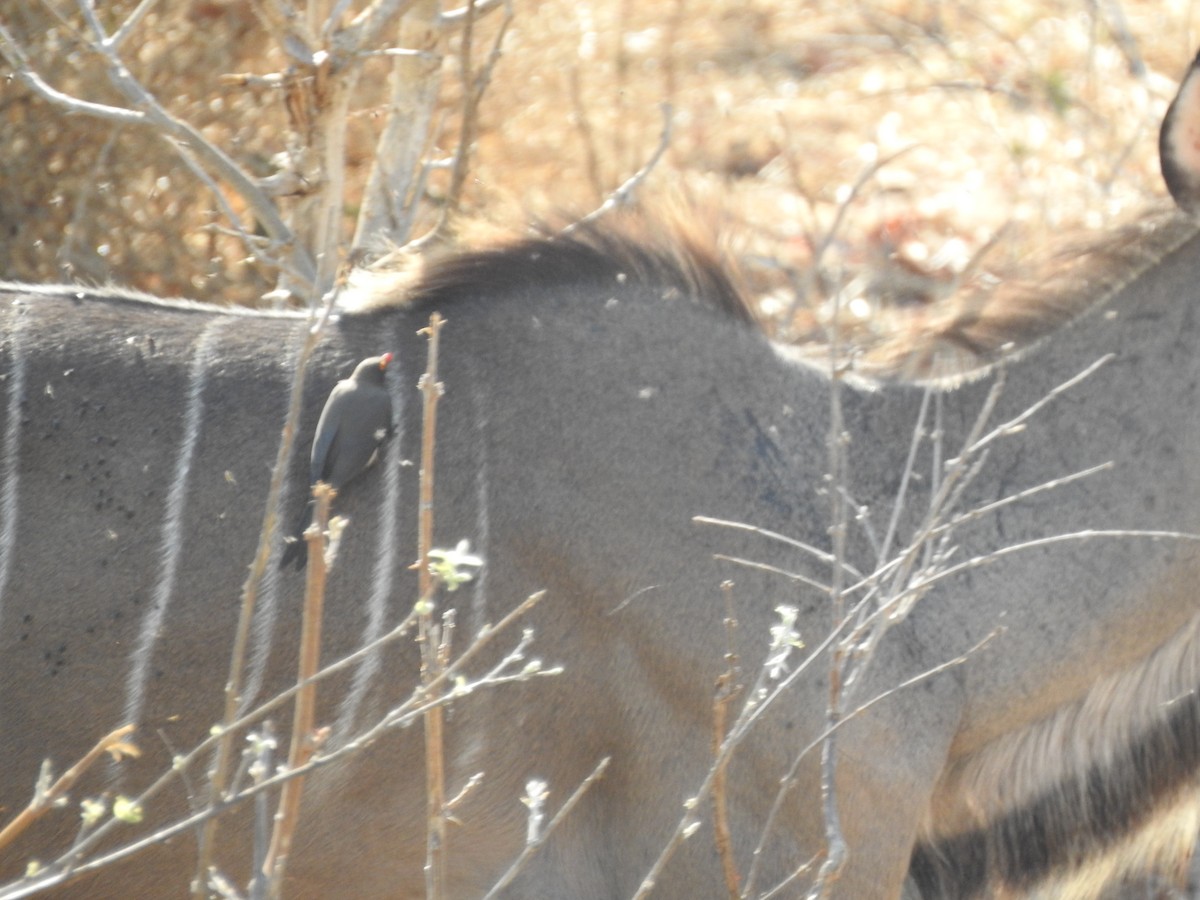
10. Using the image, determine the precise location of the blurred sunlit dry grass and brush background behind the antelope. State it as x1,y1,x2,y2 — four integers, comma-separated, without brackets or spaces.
0,0,1198,331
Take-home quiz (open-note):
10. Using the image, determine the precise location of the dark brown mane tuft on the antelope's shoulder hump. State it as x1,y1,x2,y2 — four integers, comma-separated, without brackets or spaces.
404,216,755,324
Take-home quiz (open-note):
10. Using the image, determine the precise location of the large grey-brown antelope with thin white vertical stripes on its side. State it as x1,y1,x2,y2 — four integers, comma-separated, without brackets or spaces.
7,54,1200,899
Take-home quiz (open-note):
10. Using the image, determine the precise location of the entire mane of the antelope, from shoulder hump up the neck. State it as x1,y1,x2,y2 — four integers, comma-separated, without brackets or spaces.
348,209,1200,384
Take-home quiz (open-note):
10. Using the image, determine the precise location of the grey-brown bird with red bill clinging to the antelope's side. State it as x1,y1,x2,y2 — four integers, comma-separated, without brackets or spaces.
280,353,392,569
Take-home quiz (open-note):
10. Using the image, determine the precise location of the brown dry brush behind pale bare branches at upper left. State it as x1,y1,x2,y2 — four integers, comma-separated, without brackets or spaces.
0,0,273,299
